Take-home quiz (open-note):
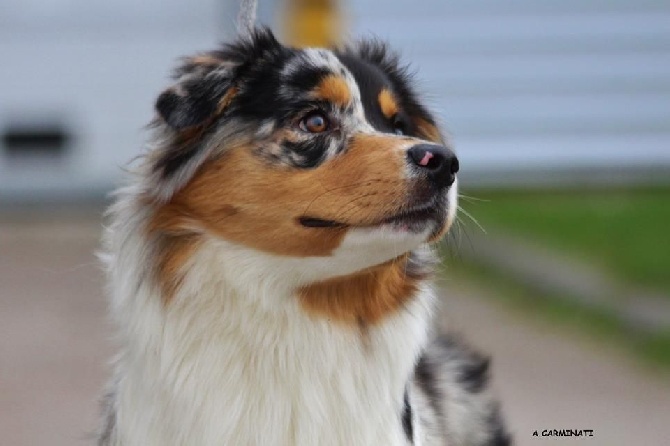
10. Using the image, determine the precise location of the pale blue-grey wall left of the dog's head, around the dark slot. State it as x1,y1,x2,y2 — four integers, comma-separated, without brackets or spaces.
0,0,235,199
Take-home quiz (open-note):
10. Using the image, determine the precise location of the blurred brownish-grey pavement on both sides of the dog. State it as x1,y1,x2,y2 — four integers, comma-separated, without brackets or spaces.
0,213,670,446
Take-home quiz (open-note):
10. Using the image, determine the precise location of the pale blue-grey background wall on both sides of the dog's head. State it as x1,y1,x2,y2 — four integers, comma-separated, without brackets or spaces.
0,0,670,199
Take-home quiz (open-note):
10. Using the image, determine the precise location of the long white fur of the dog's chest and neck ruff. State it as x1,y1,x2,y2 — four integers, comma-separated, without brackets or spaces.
102,186,432,446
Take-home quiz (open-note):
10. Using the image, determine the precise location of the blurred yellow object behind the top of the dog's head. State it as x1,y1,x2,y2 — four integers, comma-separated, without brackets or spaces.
283,0,343,47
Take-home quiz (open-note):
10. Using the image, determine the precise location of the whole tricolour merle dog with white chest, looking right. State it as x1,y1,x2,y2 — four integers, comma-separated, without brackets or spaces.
98,28,509,446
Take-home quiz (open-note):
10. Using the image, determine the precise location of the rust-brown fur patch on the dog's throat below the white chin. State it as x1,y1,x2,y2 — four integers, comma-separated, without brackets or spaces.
298,255,420,325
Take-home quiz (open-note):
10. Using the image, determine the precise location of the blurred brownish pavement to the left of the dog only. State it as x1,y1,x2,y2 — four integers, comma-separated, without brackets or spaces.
0,216,111,446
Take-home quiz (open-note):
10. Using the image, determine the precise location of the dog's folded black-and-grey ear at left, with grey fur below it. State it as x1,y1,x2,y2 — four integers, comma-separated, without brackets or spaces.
148,28,286,200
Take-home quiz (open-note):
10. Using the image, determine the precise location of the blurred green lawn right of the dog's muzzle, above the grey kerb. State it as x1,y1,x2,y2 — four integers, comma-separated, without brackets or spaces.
460,188,670,296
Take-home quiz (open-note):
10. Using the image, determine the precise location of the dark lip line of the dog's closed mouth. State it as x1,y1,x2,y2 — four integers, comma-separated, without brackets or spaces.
298,199,445,231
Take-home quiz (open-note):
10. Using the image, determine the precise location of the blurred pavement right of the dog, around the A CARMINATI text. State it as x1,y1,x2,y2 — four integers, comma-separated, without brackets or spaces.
441,281,670,446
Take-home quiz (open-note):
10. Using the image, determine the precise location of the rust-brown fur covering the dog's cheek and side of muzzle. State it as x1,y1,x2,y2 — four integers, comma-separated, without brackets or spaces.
160,135,407,257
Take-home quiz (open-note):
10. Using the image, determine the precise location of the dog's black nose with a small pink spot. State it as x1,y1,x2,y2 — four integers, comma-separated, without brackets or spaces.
407,144,458,187
